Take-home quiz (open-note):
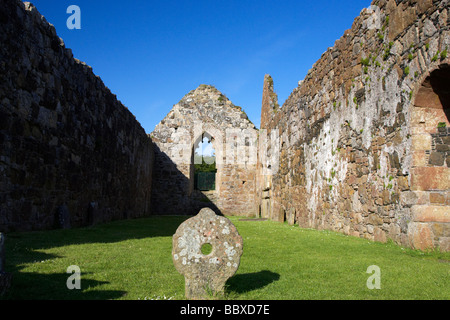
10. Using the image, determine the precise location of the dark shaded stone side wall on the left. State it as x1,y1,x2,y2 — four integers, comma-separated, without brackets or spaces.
0,0,153,231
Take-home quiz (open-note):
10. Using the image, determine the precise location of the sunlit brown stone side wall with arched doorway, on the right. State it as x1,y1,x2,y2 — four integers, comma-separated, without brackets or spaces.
257,0,450,250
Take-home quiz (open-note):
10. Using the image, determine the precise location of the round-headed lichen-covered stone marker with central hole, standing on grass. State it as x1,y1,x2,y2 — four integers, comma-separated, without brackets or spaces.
172,208,243,300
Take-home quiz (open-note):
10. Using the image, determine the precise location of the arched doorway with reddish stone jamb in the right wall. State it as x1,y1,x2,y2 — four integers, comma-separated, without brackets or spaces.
408,64,450,251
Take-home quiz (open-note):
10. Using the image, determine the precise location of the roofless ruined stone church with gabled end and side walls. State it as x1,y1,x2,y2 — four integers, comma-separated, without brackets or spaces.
0,0,450,251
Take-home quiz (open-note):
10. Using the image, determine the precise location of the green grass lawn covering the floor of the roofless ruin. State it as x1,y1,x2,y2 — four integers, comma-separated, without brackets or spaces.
3,217,450,300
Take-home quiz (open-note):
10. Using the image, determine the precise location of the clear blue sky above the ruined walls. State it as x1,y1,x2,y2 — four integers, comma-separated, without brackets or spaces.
33,0,371,133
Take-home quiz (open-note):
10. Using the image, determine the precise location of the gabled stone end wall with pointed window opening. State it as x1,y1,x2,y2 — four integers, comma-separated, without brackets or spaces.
151,85,257,216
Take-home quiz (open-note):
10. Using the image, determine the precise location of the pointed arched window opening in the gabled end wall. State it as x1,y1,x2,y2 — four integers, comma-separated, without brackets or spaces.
194,134,217,191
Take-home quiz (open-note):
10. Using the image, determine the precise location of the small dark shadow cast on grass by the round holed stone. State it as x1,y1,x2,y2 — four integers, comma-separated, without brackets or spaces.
227,270,280,294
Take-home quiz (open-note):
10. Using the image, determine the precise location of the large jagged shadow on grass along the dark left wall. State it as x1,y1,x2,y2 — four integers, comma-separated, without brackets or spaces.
0,216,190,300
